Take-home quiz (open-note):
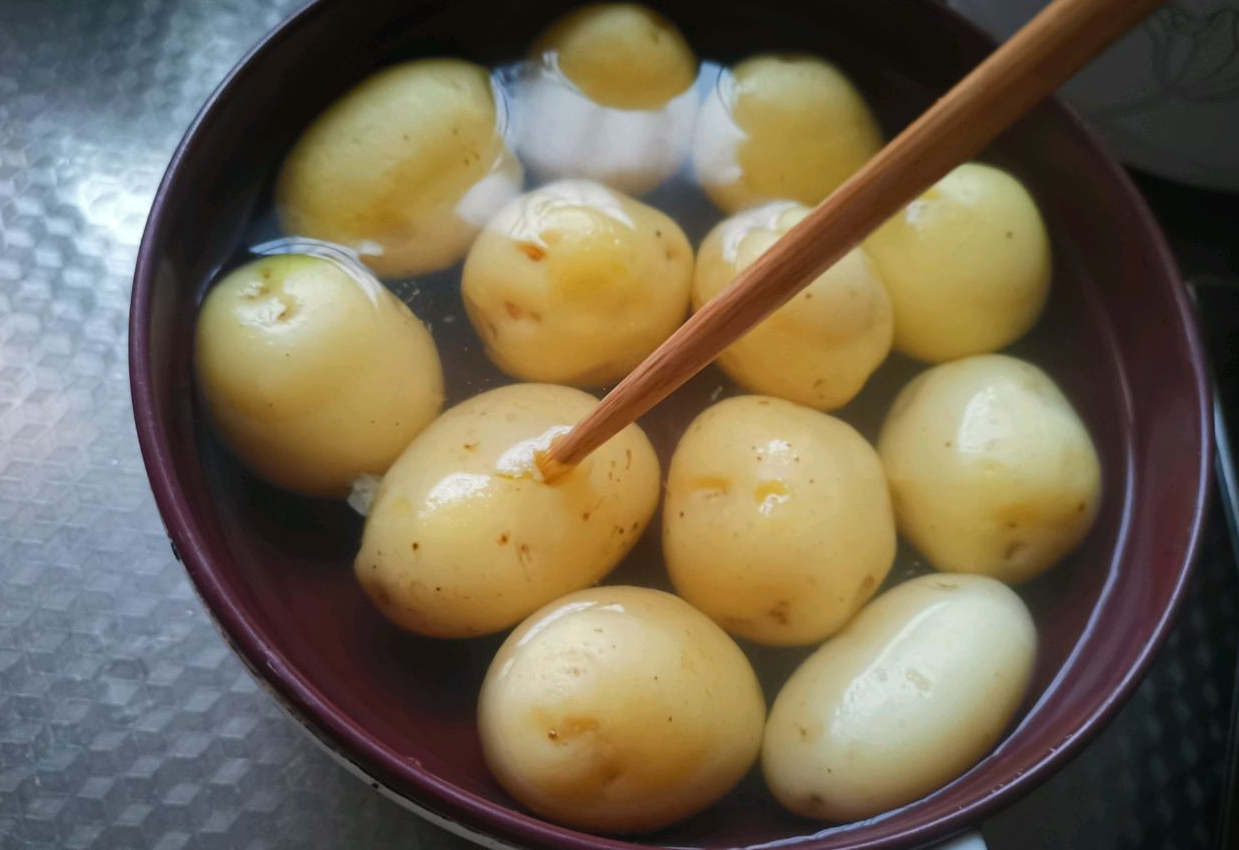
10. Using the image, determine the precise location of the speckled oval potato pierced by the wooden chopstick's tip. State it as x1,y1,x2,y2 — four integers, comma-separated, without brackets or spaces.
356,384,659,637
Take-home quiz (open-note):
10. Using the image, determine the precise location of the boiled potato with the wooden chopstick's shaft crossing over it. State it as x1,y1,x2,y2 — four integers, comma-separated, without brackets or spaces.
693,201,892,410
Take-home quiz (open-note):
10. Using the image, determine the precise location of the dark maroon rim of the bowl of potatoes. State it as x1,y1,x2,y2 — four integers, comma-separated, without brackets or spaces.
129,0,1214,850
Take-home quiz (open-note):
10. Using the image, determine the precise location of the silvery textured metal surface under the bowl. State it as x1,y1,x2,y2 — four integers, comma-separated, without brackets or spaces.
0,0,1237,850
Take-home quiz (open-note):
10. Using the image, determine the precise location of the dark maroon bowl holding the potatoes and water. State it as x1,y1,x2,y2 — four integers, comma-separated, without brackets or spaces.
130,0,1209,850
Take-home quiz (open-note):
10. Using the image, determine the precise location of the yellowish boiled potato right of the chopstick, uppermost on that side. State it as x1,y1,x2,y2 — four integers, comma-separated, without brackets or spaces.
865,162,1049,363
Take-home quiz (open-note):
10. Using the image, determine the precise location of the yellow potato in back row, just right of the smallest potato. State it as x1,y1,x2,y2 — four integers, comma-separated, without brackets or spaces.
693,53,882,213
